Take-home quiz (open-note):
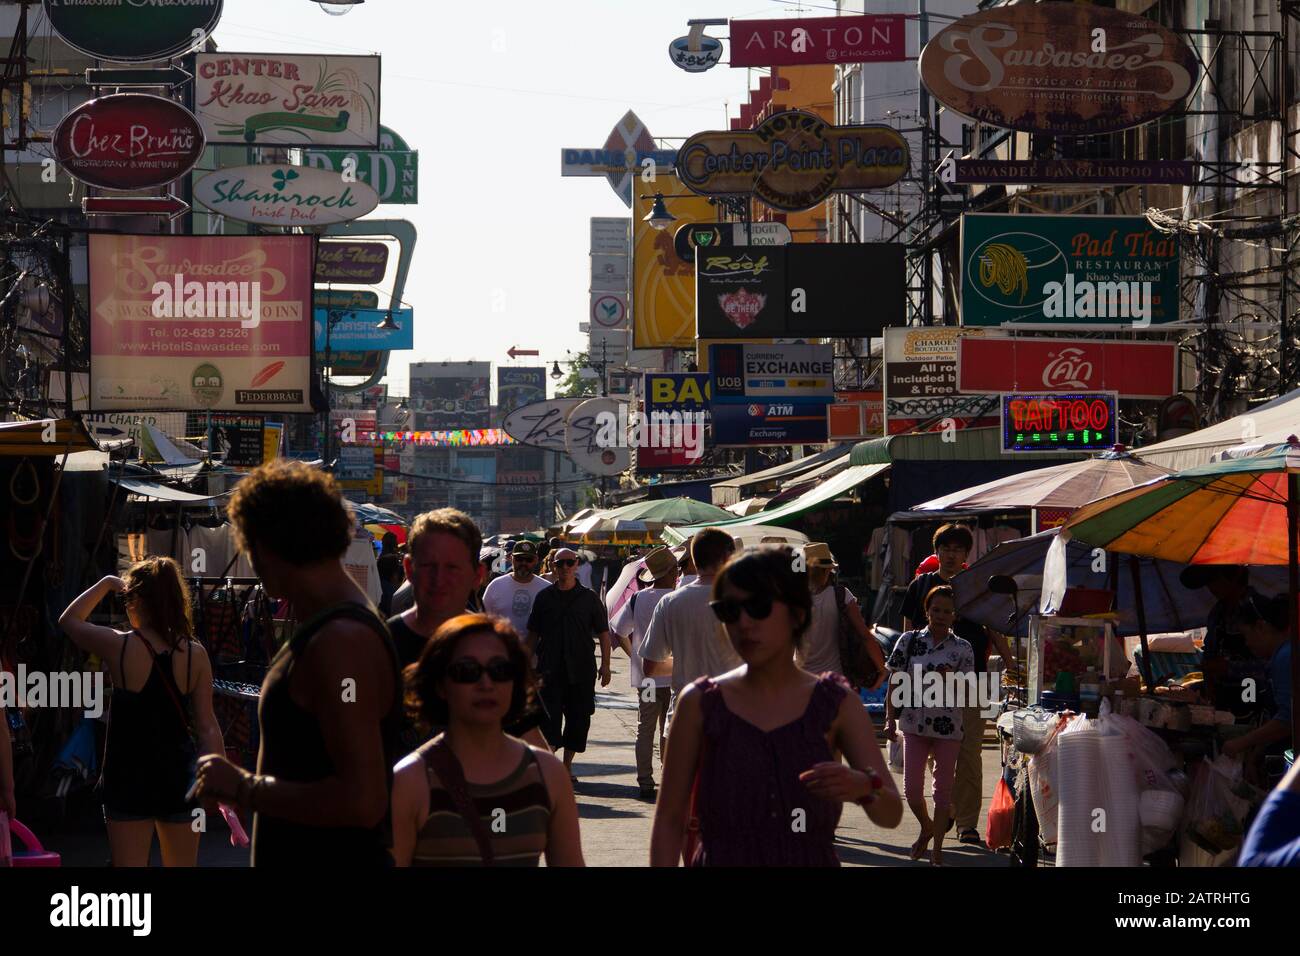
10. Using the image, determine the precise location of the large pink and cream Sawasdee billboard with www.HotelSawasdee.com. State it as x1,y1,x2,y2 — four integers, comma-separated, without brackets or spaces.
88,234,315,412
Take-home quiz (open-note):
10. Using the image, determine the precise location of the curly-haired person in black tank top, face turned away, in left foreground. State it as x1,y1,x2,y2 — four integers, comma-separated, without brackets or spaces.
196,459,402,869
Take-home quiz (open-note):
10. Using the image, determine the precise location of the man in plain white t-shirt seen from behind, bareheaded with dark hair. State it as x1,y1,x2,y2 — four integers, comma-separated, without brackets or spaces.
641,528,741,723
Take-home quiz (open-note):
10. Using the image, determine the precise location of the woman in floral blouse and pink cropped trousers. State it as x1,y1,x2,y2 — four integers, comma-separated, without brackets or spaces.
885,585,975,866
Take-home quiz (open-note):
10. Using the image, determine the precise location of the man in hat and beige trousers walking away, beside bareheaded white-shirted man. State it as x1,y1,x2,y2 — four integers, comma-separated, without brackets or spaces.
610,548,677,800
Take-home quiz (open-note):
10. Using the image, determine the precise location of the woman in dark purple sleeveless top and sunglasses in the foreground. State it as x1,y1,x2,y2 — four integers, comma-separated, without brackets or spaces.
650,548,902,866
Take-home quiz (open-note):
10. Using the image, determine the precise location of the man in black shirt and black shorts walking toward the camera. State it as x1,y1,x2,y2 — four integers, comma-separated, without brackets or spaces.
528,548,610,775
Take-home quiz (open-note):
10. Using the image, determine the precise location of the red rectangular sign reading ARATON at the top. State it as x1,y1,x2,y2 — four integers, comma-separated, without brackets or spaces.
731,16,907,66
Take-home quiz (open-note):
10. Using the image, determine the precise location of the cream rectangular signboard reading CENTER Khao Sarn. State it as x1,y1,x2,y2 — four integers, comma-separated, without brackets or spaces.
194,53,380,150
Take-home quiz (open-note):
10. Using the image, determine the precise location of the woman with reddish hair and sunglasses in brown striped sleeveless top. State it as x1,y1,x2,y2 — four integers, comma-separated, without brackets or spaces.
393,614,582,866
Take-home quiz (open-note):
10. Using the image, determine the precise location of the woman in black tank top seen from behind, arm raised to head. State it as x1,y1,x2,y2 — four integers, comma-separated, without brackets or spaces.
59,558,224,866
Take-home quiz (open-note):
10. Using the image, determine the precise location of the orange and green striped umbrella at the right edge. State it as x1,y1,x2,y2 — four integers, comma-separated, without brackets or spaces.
1062,436,1300,740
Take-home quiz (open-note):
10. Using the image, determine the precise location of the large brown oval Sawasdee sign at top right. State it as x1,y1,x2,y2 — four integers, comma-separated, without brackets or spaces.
920,3,1197,135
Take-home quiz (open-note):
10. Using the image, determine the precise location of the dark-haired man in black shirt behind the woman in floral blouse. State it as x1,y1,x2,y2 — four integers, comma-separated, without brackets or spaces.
902,524,1011,845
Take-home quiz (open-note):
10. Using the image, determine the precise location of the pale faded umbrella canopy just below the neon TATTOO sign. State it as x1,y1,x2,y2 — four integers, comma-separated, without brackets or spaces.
911,447,1169,512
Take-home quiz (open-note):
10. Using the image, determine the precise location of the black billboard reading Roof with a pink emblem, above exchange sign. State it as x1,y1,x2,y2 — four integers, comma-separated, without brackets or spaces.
696,242,907,338
